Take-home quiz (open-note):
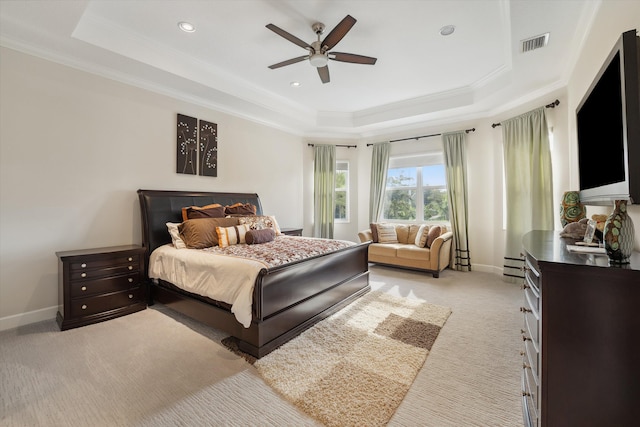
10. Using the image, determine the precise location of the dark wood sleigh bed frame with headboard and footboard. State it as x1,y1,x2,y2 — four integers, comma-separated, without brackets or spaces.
138,190,370,358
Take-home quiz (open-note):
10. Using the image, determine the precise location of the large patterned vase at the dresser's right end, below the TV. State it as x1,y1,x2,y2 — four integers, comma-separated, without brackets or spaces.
603,200,634,264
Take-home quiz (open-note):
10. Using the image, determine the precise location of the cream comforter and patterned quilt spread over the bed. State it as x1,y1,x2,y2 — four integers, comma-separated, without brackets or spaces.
149,236,354,328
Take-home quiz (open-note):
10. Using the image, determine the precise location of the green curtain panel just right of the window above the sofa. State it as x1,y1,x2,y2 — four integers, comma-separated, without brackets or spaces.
442,131,471,271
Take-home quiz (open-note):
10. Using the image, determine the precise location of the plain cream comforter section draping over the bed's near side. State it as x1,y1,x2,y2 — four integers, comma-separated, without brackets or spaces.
149,244,268,328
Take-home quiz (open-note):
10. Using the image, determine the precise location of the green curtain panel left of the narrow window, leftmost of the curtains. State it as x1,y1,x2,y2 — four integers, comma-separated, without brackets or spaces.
313,144,336,239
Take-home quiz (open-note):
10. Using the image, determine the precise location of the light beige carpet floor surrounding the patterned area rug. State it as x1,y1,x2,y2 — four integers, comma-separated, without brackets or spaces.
0,266,522,427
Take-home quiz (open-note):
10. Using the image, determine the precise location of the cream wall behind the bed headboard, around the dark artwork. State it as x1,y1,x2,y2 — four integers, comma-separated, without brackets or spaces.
0,48,307,329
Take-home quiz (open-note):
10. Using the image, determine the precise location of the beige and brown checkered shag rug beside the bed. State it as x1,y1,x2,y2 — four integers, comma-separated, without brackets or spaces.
225,292,451,426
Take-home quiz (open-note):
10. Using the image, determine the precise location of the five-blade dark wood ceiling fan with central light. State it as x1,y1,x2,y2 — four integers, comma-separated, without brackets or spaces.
266,15,377,83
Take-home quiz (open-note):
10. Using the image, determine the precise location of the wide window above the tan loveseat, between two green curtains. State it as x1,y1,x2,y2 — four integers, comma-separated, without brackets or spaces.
382,153,449,222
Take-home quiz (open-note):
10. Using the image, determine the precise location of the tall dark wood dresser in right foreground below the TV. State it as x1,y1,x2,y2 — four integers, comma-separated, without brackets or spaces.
520,231,640,427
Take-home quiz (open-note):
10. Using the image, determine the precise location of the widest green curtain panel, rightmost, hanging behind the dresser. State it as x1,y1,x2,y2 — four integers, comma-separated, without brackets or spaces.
502,107,553,282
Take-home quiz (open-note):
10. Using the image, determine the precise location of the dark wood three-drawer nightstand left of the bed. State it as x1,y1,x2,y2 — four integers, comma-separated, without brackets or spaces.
56,245,147,331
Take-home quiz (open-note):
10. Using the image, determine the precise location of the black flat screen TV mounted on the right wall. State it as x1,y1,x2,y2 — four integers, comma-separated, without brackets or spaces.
576,30,640,204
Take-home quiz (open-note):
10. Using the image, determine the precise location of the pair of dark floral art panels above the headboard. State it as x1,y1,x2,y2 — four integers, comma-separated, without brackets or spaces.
176,114,218,177
